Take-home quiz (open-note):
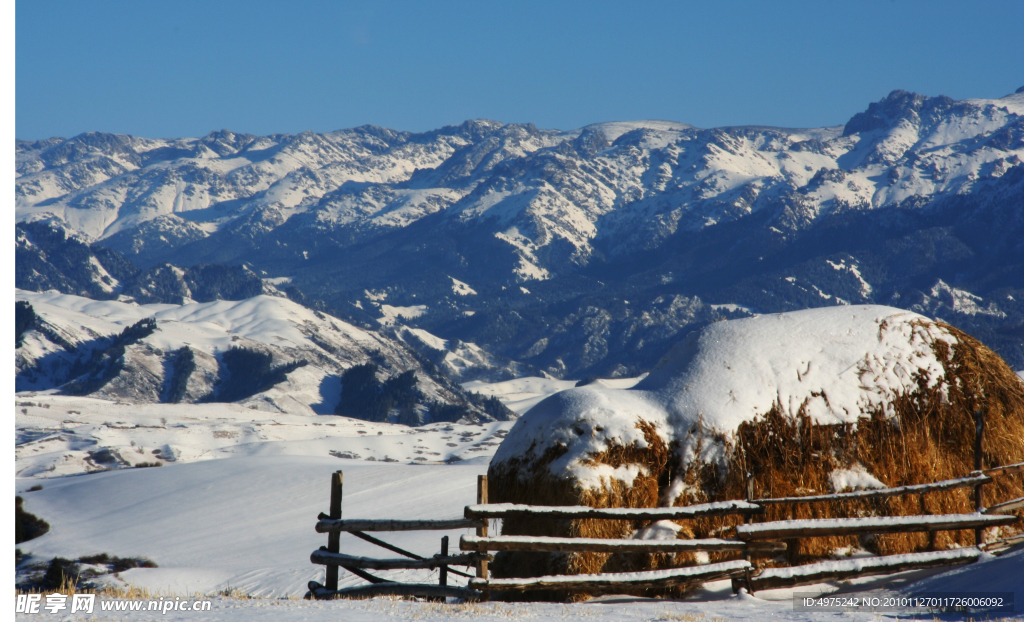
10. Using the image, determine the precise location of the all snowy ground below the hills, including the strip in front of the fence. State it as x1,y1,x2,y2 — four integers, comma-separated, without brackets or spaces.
15,378,1024,622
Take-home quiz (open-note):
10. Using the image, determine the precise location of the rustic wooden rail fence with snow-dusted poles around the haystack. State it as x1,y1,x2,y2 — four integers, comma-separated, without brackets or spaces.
309,463,1024,599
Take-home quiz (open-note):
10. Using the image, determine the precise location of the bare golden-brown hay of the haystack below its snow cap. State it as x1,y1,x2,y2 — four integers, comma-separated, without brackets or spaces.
488,324,1024,599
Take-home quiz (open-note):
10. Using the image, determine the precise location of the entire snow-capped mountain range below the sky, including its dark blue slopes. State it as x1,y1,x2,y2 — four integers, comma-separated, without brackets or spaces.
16,91,1024,376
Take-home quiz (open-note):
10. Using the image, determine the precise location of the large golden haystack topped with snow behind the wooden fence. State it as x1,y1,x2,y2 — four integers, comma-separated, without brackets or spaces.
488,306,1024,594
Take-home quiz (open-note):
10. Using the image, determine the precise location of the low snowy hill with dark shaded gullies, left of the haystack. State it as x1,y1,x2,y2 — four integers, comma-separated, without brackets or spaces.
15,291,509,421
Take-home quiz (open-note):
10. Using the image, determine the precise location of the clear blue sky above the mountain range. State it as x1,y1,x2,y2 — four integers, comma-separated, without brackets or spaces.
15,0,1024,139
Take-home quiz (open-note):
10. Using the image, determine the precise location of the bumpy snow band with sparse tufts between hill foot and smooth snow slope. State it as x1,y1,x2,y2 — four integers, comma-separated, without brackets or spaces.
15,396,512,479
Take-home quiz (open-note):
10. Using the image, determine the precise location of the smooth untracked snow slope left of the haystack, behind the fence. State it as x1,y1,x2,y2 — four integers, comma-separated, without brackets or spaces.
18,457,487,596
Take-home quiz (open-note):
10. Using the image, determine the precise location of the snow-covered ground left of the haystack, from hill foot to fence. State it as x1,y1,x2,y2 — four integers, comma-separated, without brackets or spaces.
15,382,572,596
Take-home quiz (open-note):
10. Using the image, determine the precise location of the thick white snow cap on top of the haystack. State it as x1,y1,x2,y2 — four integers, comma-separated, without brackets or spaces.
494,305,956,487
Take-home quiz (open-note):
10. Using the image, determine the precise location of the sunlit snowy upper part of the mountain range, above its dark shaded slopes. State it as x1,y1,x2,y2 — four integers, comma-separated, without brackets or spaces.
16,91,1024,270
